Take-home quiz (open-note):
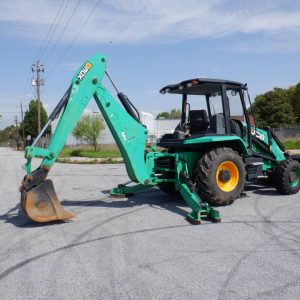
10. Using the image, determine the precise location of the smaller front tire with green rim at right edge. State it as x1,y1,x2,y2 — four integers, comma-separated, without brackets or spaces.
273,158,300,195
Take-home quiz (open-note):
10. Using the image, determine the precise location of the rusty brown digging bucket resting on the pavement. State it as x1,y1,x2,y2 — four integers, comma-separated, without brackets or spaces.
21,179,75,222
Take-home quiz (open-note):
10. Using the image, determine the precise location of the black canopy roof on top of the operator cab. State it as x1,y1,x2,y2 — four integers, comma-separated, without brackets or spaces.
160,78,247,95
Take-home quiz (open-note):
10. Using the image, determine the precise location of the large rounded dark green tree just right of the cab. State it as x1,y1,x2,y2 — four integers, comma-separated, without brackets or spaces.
252,88,296,128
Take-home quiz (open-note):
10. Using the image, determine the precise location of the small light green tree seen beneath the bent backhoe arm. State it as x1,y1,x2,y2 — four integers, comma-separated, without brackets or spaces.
72,114,104,151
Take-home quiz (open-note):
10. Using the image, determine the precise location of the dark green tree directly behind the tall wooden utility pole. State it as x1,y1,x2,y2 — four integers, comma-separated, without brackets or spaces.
20,100,51,137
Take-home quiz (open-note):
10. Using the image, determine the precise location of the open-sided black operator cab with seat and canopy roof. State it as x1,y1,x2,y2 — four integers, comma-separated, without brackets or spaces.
159,78,250,147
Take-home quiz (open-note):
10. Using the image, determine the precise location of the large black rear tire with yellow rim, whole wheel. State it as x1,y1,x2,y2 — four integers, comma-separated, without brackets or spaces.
195,148,246,205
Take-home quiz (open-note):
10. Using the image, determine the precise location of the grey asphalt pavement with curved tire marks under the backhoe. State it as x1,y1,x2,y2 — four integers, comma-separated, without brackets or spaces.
0,148,300,299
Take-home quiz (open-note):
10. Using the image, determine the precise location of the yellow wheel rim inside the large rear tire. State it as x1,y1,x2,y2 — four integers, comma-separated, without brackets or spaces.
216,160,240,192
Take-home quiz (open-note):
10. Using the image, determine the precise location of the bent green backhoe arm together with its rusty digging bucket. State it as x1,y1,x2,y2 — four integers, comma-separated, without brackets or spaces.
21,54,151,222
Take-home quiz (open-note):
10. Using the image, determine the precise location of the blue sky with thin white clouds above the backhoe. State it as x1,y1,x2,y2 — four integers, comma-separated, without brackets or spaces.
0,0,300,128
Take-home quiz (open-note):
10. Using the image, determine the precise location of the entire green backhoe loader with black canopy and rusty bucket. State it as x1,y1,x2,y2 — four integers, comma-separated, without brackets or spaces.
20,54,300,224
